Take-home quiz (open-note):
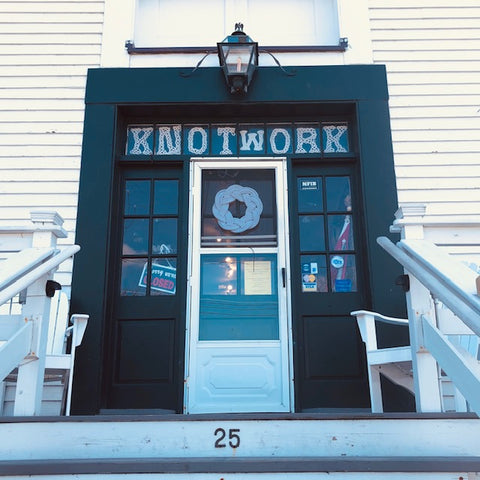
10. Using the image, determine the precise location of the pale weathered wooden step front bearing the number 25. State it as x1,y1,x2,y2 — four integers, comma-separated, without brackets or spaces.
0,414,480,462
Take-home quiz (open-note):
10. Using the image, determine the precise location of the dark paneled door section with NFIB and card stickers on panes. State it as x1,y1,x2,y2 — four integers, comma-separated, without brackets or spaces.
290,163,369,411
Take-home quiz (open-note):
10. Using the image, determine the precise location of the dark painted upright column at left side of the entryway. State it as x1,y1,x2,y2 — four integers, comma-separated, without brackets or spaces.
71,105,116,414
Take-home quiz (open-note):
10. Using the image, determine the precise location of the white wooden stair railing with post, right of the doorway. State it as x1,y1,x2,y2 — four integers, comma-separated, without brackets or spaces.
377,237,480,413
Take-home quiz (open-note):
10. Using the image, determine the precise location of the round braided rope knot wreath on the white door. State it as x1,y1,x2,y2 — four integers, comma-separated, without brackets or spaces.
212,185,263,233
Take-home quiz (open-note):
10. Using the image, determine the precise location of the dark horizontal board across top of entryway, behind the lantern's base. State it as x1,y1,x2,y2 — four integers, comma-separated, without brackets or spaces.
86,65,388,104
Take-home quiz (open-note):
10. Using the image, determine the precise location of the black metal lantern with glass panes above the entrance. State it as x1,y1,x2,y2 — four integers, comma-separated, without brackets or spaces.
217,23,258,93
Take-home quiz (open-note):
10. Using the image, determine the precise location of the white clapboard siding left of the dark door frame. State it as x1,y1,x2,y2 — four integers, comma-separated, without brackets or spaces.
0,0,104,285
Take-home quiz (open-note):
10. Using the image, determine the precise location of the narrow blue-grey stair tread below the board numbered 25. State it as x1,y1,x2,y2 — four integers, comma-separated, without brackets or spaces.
0,456,480,475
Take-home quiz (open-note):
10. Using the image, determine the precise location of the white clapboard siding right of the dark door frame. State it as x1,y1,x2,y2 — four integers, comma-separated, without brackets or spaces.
368,0,480,219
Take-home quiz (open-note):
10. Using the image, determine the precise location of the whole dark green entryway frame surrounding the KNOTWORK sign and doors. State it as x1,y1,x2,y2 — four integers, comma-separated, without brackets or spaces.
71,65,404,414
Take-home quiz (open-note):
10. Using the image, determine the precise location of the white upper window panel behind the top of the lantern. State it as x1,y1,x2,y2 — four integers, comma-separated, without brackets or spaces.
135,0,339,47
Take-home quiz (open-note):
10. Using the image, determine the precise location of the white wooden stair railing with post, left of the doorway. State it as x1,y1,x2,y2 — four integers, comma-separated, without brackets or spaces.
0,212,84,415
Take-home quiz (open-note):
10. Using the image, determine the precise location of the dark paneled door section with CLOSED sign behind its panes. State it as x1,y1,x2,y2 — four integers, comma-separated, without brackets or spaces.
104,167,186,412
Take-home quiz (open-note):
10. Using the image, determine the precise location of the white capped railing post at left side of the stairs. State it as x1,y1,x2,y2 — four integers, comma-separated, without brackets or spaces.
14,211,67,416
